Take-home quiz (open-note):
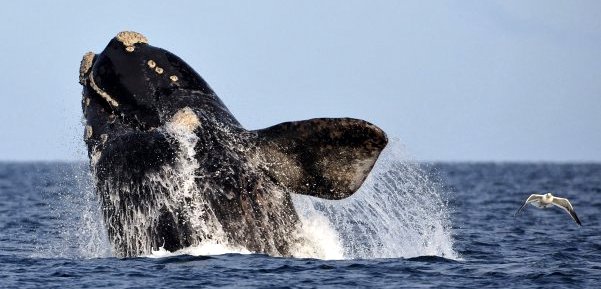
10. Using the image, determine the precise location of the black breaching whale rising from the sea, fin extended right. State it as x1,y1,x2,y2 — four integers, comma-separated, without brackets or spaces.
79,31,387,257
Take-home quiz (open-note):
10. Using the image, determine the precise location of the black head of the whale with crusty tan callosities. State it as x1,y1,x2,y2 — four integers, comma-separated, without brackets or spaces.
80,31,229,130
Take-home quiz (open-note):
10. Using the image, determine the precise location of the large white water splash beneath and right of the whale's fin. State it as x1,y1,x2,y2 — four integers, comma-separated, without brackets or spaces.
293,140,458,259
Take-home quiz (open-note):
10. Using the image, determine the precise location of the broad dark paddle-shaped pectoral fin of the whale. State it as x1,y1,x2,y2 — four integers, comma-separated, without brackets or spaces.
255,118,388,200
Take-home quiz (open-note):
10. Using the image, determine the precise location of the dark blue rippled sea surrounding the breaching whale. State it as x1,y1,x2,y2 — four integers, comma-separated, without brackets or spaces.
0,162,601,288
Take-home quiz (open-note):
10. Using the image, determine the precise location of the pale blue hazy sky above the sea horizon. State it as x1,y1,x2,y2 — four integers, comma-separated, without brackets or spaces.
0,0,601,161
